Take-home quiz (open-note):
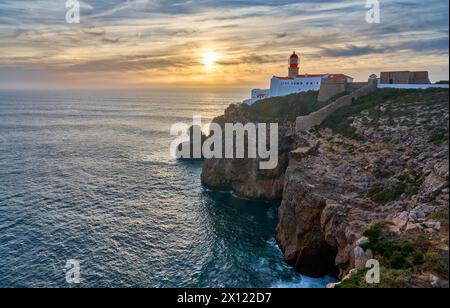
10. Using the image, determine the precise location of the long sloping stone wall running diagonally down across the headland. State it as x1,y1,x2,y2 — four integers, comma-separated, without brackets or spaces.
296,80,377,131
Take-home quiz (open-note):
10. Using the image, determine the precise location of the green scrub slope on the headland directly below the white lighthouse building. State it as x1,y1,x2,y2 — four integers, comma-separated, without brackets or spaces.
245,91,333,122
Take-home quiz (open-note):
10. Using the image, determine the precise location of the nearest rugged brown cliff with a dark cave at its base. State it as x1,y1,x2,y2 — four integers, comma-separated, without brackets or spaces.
278,91,449,280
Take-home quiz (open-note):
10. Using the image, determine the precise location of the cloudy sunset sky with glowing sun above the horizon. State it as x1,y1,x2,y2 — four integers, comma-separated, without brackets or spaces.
0,0,449,88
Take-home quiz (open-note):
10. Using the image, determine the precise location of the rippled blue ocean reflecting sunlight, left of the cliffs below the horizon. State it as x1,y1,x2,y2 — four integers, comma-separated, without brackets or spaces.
0,89,331,288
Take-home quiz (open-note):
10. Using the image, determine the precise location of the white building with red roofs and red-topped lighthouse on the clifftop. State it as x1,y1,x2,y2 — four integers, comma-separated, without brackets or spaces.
244,51,353,105
